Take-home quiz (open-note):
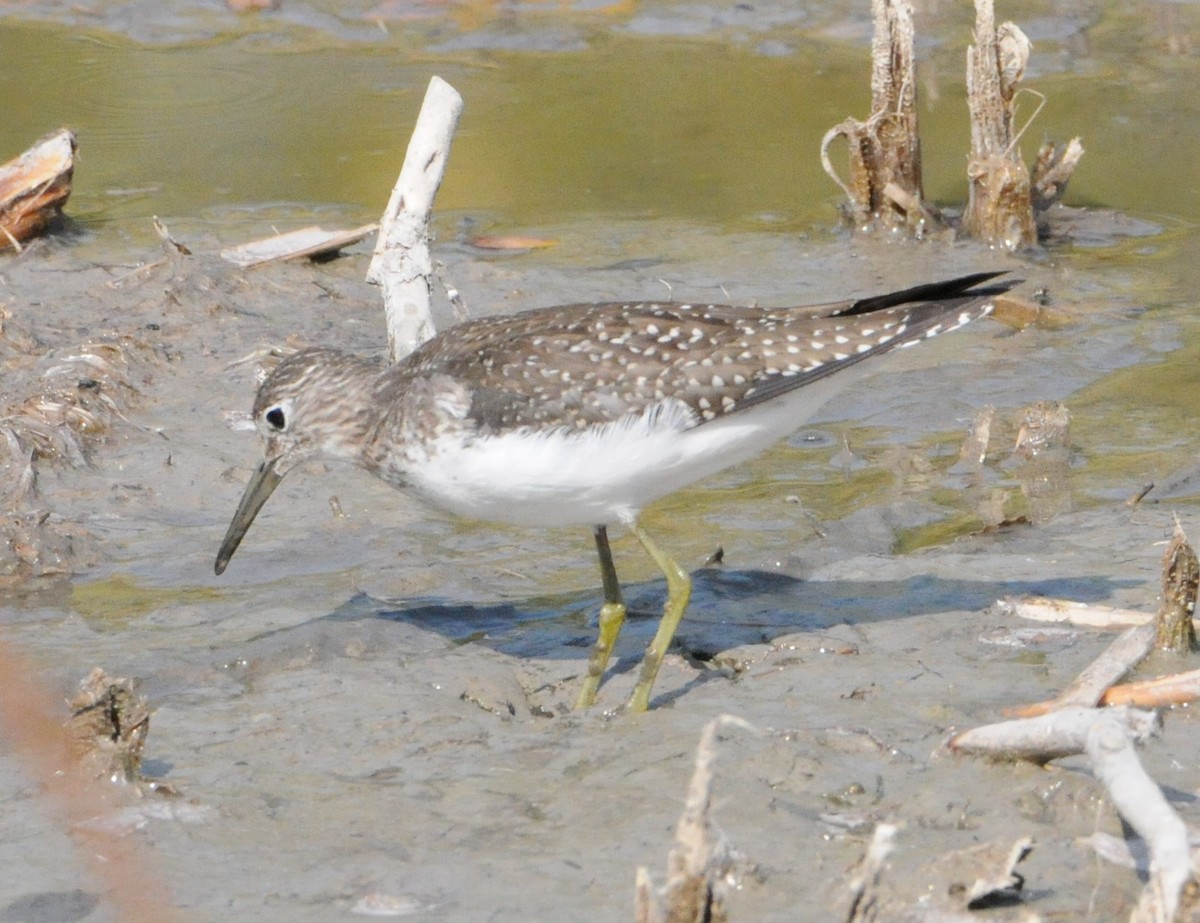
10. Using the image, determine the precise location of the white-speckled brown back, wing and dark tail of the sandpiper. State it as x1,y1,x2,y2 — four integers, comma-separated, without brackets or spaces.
407,276,998,432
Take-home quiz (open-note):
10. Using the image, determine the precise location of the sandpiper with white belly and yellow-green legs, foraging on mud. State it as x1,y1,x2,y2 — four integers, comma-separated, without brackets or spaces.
216,272,1016,711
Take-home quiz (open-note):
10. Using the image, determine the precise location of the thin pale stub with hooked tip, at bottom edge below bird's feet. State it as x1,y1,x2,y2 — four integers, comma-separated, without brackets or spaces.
634,715,754,923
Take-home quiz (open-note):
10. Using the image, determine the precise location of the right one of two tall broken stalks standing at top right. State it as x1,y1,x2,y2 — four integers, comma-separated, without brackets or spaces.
962,0,1038,250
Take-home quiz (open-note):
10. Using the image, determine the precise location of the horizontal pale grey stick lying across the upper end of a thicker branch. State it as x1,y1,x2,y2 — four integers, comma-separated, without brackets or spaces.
946,706,1162,765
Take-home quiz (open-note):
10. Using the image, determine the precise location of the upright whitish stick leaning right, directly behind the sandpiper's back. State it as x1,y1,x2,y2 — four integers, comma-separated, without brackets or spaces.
367,77,462,361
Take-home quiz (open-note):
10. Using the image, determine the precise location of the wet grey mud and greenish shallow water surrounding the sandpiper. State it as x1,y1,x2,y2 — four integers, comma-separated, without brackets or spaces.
0,2,1200,921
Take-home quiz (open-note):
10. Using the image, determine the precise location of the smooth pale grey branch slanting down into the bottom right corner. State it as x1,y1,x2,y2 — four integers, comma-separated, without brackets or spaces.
1086,709,1195,923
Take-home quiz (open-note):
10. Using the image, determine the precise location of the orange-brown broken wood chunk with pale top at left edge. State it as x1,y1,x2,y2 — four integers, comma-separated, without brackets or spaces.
0,128,76,251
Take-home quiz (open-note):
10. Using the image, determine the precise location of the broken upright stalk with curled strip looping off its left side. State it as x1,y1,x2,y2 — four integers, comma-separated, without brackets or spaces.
821,0,936,234
